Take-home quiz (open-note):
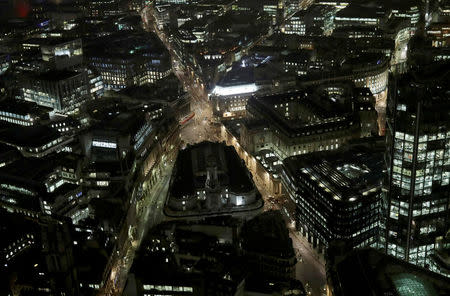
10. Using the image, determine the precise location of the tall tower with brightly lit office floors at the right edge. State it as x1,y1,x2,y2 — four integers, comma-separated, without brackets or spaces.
385,65,450,267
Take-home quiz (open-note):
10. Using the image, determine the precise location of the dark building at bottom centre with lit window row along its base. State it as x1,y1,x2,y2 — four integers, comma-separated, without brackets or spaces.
130,217,246,296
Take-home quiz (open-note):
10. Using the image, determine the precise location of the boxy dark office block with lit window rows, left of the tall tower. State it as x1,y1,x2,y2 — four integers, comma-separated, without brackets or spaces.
281,140,384,252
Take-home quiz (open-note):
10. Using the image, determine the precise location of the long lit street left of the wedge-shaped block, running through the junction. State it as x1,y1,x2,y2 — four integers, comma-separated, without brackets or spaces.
100,5,223,295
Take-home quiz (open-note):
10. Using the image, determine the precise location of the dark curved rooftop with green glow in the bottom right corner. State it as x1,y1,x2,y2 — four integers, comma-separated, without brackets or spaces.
327,249,450,296
